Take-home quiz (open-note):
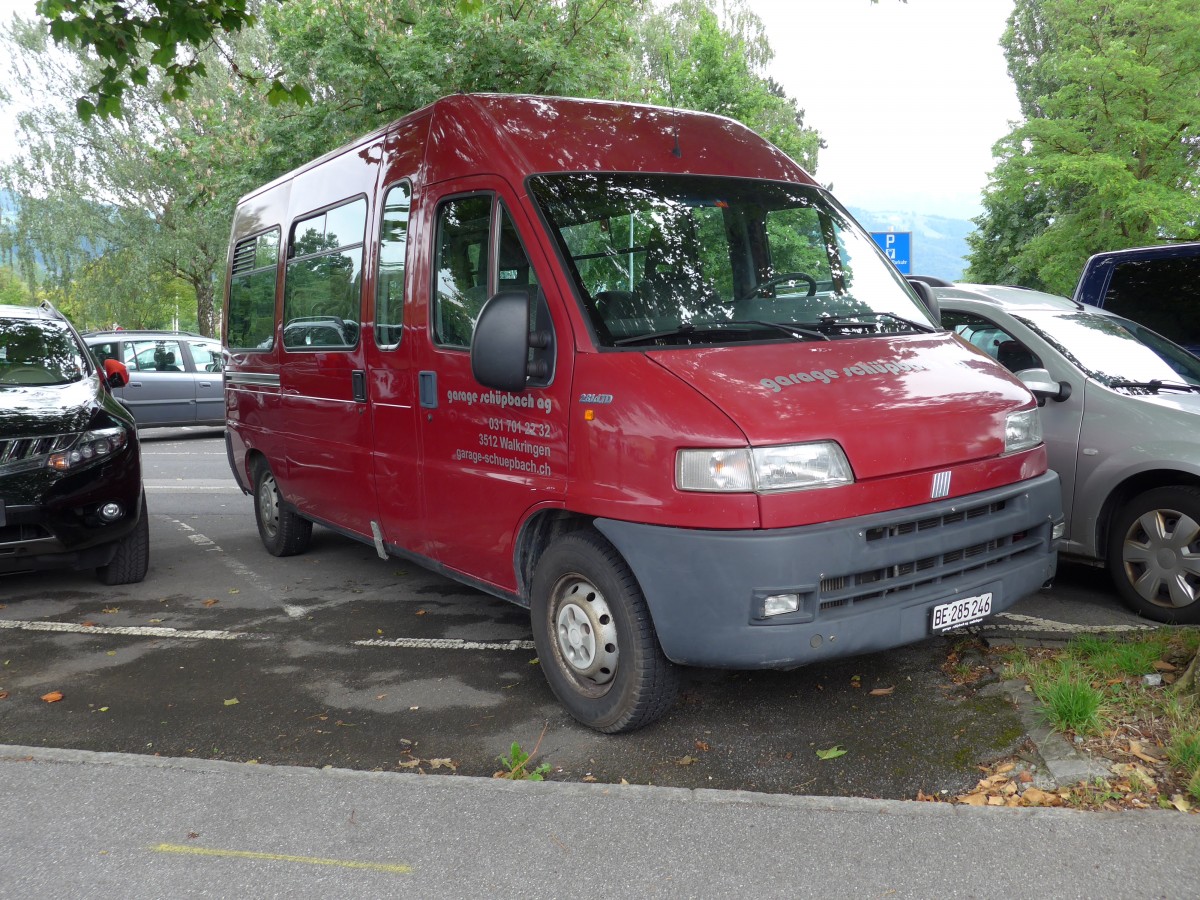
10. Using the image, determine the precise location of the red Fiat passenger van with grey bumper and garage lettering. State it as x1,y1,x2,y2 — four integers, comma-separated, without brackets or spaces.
223,95,1062,732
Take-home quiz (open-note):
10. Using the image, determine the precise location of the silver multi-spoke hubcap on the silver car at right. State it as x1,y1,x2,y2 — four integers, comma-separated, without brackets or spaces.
1122,509,1200,608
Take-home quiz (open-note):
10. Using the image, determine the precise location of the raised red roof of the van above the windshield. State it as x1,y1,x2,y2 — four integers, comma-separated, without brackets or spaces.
237,94,816,199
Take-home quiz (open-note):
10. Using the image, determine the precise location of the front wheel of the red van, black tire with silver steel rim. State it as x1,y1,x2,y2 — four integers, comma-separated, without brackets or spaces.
529,530,679,734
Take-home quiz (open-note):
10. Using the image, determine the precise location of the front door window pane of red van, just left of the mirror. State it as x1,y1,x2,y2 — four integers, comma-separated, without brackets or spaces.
433,194,492,348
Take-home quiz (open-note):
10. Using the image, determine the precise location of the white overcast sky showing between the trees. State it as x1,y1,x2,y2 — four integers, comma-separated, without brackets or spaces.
0,0,1019,217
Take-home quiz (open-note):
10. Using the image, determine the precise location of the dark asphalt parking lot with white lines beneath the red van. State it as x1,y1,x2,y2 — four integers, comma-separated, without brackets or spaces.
0,430,1161,799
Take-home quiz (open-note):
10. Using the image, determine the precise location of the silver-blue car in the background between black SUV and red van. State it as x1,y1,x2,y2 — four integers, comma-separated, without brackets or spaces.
83,331,224,428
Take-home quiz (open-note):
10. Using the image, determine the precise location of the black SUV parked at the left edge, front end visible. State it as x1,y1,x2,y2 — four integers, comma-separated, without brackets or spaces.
0,304,150,584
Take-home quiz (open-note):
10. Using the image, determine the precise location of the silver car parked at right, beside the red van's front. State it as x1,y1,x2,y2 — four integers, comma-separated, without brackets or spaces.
932,284,1200,624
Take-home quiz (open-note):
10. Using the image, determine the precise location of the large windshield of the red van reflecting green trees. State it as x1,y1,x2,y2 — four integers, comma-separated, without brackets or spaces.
529,173,936,348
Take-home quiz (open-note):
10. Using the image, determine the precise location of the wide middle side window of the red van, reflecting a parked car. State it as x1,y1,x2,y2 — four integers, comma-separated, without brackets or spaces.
283,199,367,350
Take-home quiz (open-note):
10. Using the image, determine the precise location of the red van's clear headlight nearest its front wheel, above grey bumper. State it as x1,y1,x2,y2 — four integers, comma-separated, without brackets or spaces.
676,440,854,493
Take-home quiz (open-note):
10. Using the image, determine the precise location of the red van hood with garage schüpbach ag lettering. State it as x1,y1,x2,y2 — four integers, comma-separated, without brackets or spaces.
647,334,1033,480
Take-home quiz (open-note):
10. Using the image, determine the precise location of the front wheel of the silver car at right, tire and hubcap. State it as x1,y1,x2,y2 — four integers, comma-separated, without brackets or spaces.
1108,485,1200,624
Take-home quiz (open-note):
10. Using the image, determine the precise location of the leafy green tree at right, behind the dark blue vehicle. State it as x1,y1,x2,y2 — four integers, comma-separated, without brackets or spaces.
967,0,1200,294
